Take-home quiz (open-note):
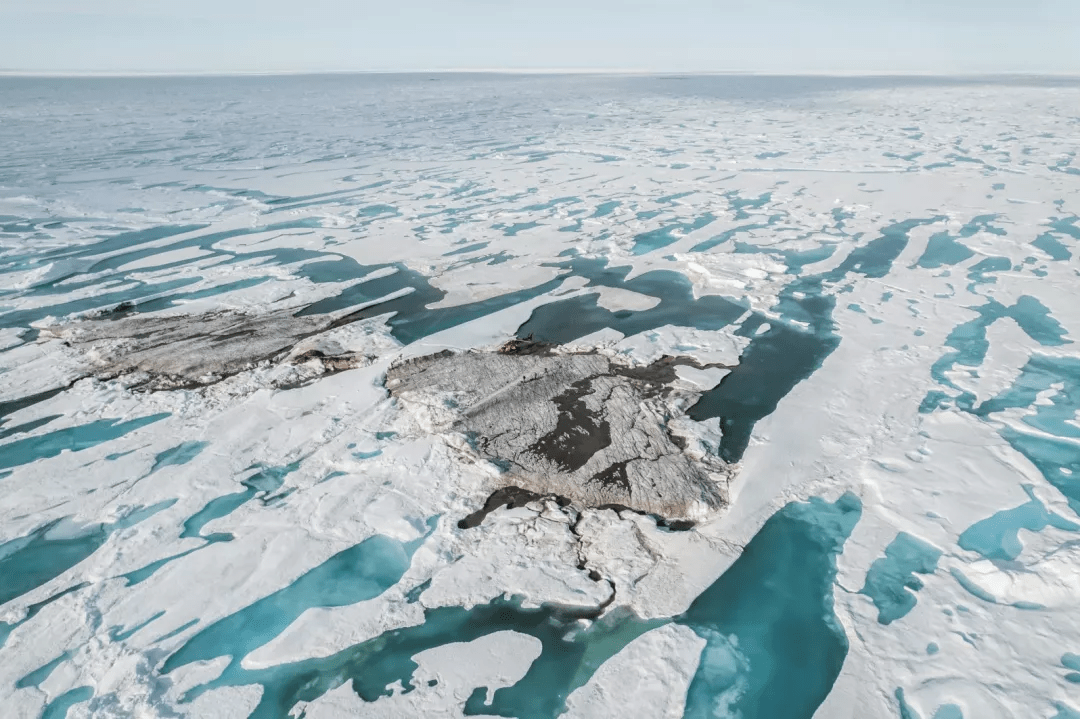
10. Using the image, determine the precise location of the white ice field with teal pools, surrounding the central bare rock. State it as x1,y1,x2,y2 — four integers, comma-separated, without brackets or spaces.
0,74,1080,719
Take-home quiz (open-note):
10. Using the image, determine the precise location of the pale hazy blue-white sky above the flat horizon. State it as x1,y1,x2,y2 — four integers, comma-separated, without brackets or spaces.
0,0,1080,74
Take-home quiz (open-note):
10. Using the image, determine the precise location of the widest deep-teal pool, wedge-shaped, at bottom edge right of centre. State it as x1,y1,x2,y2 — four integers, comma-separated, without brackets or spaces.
675,494,862,719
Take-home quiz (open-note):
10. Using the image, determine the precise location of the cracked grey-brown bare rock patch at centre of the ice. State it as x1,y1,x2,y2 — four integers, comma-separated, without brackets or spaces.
387,340,730,525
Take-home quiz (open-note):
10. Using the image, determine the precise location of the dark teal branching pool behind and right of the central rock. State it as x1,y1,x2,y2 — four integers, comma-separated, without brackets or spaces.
517,218,941,461
